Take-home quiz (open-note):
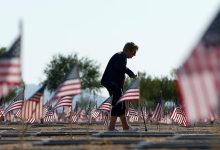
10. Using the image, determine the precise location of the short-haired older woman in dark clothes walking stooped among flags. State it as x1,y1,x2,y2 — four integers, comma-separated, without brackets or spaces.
101,42,138,131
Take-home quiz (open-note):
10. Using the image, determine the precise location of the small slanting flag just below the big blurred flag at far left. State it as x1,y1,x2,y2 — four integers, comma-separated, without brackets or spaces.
5,90,24,114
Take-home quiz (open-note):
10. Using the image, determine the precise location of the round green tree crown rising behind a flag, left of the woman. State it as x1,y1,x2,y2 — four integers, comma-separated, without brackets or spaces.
44,54,101,93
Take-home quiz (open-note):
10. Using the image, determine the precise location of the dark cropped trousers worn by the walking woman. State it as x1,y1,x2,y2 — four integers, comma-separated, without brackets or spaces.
105,84,126,117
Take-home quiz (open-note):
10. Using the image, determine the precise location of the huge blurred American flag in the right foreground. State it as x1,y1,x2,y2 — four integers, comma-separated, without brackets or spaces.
177,9,220,122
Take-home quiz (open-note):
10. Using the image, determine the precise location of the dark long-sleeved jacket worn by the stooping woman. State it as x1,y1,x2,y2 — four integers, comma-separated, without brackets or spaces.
101,52,134,88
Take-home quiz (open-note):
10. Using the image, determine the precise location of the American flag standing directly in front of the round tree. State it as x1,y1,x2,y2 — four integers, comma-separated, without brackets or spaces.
51,67,81,102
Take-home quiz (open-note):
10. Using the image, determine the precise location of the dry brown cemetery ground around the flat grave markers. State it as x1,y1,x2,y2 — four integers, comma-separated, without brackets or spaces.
0,121,220,150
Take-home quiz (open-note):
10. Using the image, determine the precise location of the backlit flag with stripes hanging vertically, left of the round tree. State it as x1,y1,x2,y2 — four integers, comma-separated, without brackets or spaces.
22,85,46,122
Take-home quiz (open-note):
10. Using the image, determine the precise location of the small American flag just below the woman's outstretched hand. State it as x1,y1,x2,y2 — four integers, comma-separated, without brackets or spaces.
117,79,140,104
